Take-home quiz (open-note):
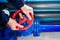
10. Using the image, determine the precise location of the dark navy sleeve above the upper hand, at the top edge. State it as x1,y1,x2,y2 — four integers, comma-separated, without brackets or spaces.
7,0,24,9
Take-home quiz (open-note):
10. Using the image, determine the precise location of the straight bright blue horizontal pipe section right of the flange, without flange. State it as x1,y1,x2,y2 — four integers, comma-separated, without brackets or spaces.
40,25,60,32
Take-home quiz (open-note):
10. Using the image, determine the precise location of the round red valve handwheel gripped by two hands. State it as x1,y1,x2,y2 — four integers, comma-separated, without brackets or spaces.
12,10,34,30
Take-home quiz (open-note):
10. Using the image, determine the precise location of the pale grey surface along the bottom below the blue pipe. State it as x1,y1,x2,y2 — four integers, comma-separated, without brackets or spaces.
17,32,60,40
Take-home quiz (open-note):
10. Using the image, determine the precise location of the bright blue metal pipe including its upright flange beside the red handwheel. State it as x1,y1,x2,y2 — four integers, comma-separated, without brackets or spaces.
34,19,60,36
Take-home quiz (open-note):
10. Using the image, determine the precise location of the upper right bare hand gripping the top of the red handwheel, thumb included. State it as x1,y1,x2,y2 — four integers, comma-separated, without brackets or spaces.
19,5,33,20
